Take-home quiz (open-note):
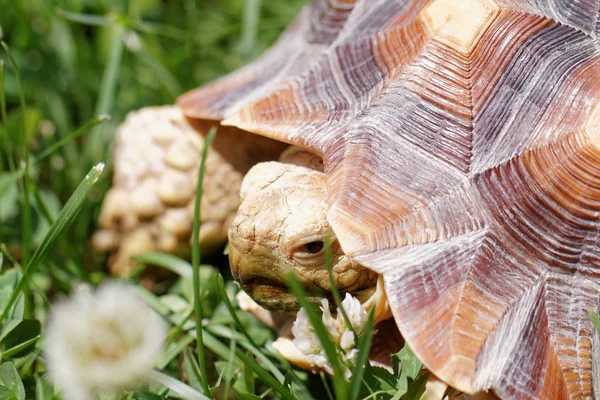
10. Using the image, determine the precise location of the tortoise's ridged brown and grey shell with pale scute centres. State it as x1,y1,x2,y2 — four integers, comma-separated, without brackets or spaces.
179,0,600,399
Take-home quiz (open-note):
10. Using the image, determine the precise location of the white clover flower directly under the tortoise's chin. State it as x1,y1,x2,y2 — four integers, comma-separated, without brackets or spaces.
292,293,368,379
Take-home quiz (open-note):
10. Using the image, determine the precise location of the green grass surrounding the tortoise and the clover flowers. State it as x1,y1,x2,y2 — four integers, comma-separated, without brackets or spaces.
0,0,432,400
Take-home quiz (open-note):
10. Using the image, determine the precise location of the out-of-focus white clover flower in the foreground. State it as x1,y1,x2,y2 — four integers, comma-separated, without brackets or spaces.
45,282,167,400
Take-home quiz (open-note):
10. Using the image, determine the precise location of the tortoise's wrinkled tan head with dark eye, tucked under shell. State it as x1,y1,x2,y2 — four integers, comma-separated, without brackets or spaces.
229,150,389,320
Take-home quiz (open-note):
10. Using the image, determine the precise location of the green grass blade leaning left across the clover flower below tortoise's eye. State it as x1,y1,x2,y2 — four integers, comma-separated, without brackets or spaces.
286,272,348,399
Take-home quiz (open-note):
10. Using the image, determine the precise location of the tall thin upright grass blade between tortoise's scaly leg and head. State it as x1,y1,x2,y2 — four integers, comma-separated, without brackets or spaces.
192,128,217,394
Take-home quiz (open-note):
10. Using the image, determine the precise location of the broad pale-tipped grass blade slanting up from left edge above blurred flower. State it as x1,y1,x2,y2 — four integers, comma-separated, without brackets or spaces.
0,163,104,325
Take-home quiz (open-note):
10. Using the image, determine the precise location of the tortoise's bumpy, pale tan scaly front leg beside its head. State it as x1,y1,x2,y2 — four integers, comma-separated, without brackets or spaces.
93,106,242,275
